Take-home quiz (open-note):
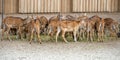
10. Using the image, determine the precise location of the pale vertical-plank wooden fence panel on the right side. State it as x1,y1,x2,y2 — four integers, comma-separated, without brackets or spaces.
73,0,118,12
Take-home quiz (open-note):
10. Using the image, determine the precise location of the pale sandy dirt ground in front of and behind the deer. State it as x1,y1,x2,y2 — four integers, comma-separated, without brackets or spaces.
0,13,120,60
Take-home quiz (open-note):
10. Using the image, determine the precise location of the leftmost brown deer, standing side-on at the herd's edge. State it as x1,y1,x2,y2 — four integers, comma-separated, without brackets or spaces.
2,16,24,41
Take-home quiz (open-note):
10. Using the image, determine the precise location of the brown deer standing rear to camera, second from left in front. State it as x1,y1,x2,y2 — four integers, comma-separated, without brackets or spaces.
24,17,41,44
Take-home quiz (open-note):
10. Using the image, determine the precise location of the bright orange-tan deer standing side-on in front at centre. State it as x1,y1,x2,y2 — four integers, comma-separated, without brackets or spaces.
56,19,85,43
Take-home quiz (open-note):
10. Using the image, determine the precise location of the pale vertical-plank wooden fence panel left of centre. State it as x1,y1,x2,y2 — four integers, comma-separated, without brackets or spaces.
19,0,60,13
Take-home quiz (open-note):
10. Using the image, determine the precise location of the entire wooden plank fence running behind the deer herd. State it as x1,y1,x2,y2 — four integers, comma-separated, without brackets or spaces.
0,0,120,13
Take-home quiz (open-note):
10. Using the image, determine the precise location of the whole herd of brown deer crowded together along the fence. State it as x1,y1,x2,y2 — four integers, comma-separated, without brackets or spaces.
1,15,119,44
